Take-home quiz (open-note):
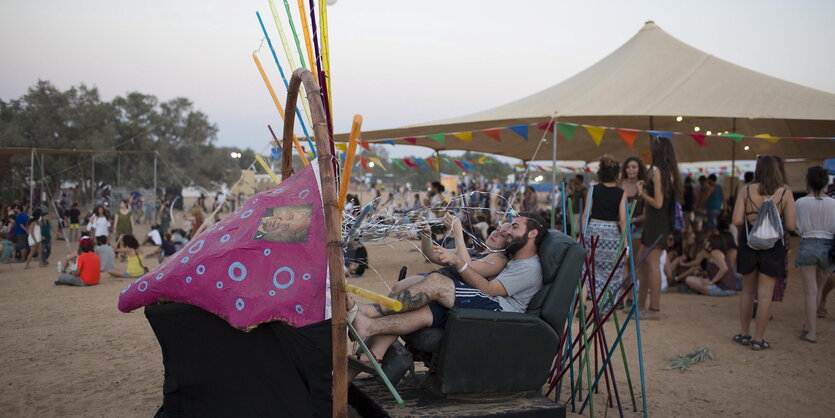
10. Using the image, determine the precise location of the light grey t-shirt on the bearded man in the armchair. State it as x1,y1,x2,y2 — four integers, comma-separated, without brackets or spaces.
496,255,542,312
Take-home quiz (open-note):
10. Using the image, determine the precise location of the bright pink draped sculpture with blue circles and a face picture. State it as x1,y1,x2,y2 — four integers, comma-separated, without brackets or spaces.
119,164,328,329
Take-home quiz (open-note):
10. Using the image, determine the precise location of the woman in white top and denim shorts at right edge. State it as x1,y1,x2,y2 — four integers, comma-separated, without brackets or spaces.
794,166,835,343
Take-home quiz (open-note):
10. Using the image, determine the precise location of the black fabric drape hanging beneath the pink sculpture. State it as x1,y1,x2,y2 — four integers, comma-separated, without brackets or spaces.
145,303,332,417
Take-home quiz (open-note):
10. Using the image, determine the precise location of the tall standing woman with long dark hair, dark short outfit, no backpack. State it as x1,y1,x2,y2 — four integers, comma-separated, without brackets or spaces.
636,136,681,319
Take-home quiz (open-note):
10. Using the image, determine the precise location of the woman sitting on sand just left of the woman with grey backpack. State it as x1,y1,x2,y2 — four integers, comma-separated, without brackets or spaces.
684,234,736,296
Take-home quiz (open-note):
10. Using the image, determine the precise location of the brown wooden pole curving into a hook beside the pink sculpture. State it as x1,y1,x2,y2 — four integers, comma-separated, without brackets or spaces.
284,68,348,417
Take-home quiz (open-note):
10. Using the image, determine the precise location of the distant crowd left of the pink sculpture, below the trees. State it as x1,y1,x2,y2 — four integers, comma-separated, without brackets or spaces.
0,194,216,286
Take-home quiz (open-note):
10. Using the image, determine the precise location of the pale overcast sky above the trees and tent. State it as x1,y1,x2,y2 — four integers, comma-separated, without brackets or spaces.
0,0,835,156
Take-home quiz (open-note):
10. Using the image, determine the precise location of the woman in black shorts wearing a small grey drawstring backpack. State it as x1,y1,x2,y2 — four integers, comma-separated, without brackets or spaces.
733,155,796,351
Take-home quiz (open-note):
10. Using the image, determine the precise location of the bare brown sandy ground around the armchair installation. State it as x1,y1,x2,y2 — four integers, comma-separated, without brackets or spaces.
0,222,835,417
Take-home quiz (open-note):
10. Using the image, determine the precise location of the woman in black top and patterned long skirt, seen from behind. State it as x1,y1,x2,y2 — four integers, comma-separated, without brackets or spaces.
583,157,626,314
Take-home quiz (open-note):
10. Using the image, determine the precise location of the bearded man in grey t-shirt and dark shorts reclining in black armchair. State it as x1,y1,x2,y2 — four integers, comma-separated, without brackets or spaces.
349,212,548,372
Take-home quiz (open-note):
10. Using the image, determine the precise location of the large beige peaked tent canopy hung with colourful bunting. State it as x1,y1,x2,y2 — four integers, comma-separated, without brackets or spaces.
336,21,835,162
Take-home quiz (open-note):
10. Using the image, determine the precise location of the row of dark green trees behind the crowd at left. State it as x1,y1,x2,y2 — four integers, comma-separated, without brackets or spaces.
0,81,254,204
